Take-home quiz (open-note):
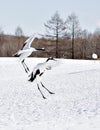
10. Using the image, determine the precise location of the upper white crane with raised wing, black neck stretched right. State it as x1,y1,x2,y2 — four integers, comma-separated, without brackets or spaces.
13,35,45,73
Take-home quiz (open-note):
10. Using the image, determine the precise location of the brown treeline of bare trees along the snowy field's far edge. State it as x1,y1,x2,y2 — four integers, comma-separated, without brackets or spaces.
0,12,100,59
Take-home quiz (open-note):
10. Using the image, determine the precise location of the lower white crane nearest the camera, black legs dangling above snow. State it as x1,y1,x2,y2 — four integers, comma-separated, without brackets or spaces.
28,57,57,99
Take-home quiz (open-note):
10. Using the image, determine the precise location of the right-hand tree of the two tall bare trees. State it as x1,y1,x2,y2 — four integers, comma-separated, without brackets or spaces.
66,13,80,59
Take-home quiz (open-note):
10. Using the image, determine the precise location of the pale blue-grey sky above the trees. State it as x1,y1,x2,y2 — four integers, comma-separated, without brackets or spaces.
0,0,100,36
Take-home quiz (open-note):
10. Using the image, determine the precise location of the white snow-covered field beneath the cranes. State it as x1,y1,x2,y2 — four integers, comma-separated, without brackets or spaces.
0,58,100,130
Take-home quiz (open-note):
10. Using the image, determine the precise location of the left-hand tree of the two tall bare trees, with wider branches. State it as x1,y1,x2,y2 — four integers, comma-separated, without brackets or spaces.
44,12,66,58
